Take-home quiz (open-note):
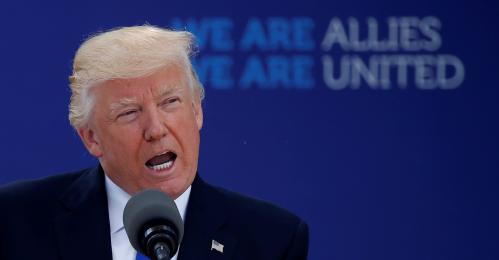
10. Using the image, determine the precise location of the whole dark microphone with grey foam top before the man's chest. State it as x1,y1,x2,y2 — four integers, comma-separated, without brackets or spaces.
123,189,184,260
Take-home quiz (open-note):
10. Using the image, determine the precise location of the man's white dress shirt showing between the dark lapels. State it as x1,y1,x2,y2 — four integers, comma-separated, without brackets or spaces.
105,175,191,260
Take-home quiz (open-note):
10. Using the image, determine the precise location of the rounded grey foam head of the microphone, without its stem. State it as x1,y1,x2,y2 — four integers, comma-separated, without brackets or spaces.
123,189,184,256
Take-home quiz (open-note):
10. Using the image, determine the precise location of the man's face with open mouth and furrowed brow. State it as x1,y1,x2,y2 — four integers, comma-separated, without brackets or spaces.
78,66,203,198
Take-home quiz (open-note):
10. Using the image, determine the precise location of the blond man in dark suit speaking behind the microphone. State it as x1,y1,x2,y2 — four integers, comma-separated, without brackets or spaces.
0,26,308,260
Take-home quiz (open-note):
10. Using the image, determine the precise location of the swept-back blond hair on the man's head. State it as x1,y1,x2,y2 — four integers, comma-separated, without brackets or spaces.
69,25,204,129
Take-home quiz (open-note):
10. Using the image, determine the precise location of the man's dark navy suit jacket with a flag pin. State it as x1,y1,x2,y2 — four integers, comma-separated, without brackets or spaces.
0,167,308,260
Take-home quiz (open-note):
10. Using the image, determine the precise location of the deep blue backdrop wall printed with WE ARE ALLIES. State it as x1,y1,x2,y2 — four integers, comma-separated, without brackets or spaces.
0,0,499,260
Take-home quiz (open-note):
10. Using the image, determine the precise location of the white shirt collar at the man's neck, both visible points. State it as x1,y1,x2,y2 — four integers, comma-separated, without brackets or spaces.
105,175,191,234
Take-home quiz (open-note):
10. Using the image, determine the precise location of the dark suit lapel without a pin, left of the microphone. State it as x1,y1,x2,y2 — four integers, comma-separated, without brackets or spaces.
54,167,112,260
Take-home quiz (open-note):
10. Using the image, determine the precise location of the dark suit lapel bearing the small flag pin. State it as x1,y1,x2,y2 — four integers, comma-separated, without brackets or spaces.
178,176,237,260
